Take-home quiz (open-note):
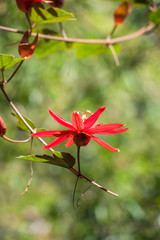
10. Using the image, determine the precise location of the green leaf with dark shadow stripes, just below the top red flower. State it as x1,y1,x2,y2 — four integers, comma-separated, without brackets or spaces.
31,8,76,24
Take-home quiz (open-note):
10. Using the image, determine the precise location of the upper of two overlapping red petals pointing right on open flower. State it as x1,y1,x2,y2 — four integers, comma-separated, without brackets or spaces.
87,123,124,134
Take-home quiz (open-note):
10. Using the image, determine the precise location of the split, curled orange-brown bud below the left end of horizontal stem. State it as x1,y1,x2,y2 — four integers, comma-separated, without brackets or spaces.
18,31,38,58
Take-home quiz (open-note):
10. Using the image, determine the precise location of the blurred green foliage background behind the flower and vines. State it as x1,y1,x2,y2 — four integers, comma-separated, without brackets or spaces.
0,0,160,240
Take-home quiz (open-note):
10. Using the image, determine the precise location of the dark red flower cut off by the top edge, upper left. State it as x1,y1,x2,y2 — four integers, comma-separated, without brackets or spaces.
16,0,52,12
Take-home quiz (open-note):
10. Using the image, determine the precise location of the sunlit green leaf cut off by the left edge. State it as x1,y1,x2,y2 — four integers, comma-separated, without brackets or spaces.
0,53,24,71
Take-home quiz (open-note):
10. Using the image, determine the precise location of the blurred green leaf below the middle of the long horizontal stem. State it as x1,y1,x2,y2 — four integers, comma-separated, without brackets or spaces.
74,43,120,58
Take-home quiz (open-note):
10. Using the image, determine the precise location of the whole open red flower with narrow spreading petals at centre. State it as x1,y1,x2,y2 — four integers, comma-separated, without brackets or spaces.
32,107,129,152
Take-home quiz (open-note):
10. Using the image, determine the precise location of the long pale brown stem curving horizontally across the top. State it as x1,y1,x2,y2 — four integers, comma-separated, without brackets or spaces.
0,23,155,44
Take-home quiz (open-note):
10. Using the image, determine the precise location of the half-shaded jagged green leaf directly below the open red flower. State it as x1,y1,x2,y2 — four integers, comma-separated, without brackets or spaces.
17,152,75,168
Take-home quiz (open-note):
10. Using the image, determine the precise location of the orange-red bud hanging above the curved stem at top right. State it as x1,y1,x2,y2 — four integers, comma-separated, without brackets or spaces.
114,1,133,25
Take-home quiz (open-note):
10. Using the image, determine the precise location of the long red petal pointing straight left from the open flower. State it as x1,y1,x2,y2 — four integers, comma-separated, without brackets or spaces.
32,130,74,137
